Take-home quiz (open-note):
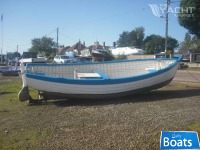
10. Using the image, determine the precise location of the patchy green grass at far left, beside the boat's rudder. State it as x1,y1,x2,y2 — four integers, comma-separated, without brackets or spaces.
0,78,48,149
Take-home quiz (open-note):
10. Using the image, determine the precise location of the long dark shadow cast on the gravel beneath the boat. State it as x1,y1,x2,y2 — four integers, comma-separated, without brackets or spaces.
50,89,200,107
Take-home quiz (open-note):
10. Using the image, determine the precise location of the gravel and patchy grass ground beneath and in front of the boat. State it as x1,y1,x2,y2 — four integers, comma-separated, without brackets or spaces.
0,77,200,150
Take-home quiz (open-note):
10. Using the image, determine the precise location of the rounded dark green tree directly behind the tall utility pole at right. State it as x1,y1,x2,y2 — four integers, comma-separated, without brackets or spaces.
144,34,178,54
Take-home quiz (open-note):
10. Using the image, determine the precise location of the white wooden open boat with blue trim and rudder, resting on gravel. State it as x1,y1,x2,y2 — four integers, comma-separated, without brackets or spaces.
18,58,181,101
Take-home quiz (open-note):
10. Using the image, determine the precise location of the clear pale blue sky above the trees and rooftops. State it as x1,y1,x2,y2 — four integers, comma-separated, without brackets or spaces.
0,0,187,54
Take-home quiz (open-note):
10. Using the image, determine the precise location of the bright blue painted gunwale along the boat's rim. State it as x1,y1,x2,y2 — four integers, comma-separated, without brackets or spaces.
26,58,181,85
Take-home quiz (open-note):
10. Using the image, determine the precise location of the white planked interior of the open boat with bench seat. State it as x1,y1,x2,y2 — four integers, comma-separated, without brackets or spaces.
26,59,176,79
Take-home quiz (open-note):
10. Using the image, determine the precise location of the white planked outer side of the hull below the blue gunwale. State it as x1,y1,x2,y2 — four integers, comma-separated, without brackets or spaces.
27,64,177,94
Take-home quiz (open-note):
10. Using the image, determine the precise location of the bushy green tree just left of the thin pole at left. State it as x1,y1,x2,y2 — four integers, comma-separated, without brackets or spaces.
29,37,56,56
